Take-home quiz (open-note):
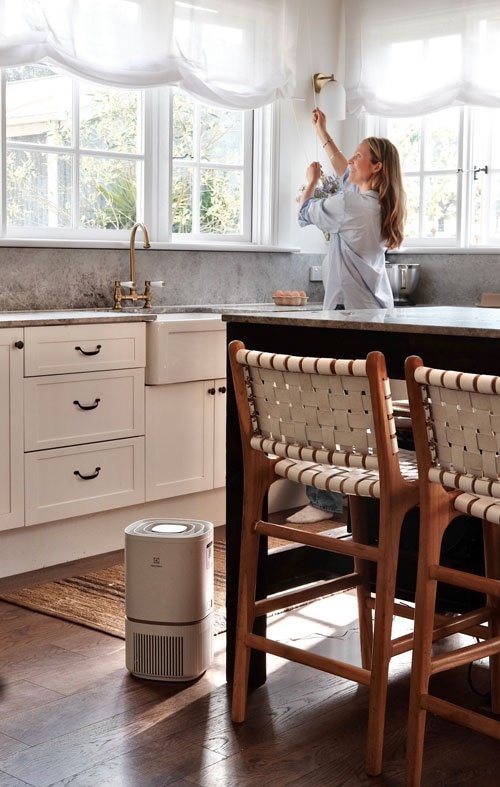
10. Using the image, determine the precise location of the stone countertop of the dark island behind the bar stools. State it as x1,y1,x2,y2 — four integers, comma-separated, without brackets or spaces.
222,306,500,339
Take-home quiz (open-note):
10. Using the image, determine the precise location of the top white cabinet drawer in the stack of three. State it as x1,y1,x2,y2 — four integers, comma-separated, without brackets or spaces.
24,323,146,377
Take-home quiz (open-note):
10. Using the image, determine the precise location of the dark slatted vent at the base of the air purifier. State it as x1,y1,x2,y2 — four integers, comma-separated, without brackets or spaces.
133,633,184,678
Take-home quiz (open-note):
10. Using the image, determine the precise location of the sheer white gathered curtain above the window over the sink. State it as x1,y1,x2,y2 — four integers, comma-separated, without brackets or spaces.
0,0,299,109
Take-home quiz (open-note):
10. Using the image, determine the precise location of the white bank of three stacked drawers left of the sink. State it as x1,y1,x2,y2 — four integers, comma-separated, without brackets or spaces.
24,323,145,525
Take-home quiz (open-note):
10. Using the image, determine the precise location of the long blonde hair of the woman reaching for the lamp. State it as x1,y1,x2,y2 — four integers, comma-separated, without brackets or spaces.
365,137,406,250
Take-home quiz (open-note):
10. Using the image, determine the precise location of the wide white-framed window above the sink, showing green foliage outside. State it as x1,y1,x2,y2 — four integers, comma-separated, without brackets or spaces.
2,65,253,242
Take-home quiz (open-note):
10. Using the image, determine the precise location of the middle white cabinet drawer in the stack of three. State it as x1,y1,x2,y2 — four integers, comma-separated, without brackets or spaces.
24,369,144,451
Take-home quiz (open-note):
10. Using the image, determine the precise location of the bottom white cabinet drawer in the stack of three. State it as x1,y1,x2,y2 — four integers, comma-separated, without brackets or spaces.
25,437,144,525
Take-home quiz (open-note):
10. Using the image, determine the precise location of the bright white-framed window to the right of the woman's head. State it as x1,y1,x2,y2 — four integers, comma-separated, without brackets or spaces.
368,107,500,248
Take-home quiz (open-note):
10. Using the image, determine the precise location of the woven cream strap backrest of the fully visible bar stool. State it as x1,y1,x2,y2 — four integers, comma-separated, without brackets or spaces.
230,342,398,469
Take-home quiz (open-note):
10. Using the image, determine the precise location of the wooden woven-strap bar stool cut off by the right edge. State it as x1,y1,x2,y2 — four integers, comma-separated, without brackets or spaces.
405,356,500,787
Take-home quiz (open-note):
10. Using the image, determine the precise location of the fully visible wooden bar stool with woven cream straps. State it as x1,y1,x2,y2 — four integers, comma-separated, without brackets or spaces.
229,341,418,775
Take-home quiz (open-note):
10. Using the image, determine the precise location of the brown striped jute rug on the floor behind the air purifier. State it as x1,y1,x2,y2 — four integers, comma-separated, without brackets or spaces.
0,541,226,639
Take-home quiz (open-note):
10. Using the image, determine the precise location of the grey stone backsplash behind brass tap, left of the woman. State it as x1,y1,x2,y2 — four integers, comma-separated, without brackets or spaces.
0,246,323,311
